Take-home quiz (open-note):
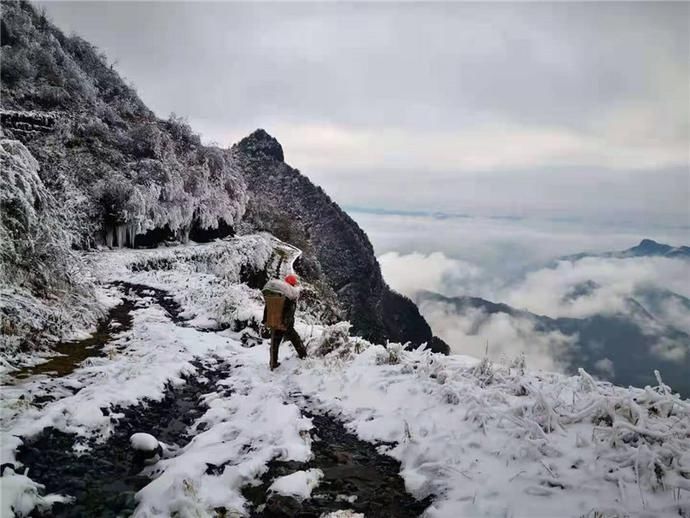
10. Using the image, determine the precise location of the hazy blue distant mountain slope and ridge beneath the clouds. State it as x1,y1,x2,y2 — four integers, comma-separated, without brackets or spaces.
415,287,690,397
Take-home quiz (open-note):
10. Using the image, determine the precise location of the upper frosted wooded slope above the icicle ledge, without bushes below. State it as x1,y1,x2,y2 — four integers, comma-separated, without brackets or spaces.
1,1,245,250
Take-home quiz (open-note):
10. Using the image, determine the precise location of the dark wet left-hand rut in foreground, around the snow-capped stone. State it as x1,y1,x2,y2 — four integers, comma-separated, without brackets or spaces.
17,361,227,518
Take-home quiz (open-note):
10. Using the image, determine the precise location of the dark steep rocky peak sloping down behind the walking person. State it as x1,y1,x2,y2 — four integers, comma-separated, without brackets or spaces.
231,129,448,353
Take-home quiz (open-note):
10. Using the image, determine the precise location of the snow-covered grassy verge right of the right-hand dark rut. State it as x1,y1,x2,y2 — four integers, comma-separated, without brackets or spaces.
281,346,690,518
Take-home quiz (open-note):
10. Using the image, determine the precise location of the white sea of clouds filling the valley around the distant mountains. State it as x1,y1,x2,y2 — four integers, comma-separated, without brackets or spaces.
353,213,690,374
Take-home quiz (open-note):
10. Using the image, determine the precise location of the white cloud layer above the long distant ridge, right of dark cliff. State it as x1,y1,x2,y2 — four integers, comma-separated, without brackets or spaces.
376,215,690,308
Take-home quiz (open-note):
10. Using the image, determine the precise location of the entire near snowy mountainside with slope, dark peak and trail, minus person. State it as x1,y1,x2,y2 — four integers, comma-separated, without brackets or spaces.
0,0,690,518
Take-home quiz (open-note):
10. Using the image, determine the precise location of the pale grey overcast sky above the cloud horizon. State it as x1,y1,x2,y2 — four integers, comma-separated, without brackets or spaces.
41,2,690,225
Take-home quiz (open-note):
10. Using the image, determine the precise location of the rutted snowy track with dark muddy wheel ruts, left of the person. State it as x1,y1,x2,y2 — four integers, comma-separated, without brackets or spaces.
1,270,420,517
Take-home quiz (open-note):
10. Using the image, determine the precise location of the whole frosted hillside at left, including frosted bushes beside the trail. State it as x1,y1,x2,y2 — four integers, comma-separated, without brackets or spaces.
0,1,246,352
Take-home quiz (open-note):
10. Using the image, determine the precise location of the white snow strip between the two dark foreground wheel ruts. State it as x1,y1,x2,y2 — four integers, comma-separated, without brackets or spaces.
135,341,312,517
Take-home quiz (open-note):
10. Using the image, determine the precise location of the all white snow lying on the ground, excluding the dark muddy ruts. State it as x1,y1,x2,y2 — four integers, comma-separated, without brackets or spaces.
0,236,690,518
